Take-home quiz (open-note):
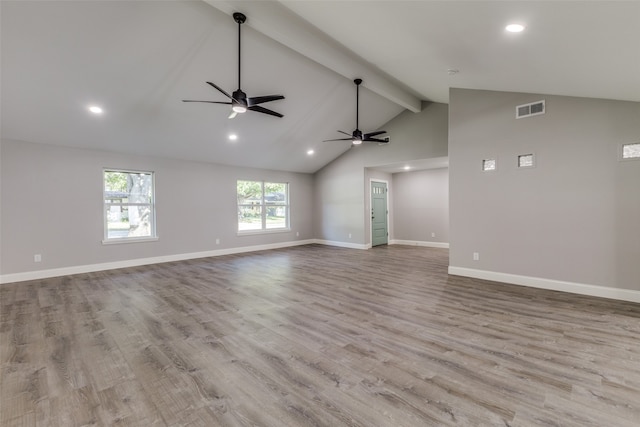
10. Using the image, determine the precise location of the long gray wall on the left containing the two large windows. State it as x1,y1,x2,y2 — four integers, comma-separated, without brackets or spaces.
0,140,314,274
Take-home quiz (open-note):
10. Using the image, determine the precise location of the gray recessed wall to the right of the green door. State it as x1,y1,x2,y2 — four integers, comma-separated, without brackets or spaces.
392,168,449,243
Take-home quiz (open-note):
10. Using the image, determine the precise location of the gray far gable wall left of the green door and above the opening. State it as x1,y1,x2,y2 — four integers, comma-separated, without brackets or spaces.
315,103,448,245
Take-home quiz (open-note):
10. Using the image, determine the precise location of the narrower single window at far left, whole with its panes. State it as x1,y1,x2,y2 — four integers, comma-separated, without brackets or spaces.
104,170,156,242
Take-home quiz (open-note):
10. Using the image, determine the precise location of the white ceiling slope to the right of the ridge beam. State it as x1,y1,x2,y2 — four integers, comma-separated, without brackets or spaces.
282,0,640,103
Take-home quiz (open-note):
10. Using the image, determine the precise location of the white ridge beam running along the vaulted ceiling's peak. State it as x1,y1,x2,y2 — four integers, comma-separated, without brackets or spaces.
204,0,422,113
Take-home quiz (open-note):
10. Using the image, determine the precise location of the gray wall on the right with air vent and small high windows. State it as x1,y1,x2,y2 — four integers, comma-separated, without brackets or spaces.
449,89,640,290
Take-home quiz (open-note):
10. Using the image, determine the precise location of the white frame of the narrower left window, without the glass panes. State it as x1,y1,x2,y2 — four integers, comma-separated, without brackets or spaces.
102,168,158,245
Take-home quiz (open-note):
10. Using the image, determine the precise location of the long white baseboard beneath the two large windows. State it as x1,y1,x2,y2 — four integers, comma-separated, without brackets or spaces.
0,239,316,284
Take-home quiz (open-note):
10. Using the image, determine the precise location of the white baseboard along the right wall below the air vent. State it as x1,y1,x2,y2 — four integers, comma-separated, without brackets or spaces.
449,266,640,303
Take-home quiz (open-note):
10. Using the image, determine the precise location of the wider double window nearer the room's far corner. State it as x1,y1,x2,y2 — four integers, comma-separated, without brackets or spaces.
237,180,289,233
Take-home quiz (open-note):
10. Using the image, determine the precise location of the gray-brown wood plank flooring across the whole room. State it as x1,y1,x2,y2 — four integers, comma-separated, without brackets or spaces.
0,245,640,427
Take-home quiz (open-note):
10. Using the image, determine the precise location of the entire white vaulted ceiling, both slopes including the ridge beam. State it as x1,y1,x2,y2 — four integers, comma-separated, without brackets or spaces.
0,0,640,172
